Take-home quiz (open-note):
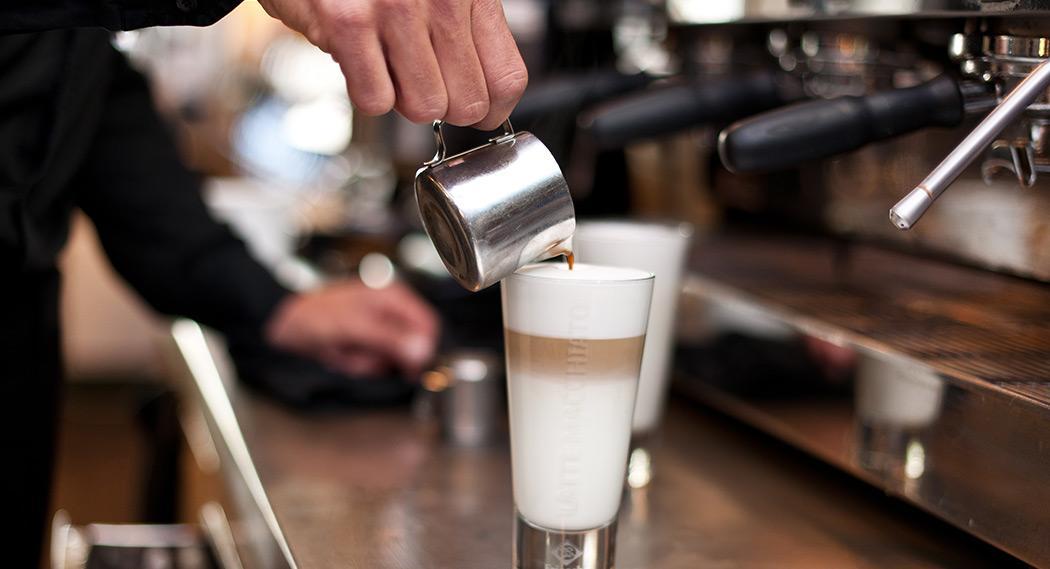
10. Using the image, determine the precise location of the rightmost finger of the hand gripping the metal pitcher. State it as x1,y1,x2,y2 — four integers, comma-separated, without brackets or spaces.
470,0,528,130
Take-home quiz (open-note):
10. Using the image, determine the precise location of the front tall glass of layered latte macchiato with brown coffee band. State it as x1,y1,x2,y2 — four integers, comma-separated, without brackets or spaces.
502,262,653,569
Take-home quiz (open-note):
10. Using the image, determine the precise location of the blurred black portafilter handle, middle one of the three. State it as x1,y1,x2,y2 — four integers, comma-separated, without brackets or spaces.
576,71,800,149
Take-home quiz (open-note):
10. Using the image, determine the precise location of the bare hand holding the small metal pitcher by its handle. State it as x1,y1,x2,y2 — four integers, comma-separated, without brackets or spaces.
259,0,528,130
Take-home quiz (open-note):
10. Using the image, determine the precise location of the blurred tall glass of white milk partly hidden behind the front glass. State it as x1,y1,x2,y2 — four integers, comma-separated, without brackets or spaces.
572,220,693,488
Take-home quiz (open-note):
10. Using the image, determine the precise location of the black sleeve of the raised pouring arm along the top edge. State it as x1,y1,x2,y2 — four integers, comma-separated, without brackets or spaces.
0,0,240,33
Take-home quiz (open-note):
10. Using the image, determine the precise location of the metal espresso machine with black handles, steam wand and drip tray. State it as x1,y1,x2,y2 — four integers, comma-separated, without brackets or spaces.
578,0,1050,566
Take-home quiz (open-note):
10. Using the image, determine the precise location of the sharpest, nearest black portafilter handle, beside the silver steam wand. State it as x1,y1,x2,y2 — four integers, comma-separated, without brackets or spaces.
718,75,966,172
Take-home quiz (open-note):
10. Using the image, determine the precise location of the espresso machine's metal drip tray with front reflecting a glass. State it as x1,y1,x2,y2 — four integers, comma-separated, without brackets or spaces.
676,235,1050,566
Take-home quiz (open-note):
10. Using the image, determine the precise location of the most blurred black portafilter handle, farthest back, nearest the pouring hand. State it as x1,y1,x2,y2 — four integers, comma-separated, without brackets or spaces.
510,69,653,126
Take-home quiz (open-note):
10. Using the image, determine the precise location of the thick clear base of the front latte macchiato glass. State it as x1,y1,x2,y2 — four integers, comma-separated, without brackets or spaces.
513,513,616,569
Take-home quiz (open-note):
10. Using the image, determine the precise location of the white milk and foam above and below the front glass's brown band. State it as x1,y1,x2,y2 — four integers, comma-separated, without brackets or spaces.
501,264,652,530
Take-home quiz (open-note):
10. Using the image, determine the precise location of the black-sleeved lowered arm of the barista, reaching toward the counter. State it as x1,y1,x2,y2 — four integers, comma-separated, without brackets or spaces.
78,46,288,331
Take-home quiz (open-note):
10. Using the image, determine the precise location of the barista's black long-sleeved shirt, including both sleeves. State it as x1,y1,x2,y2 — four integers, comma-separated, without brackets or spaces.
0,0,287,331
